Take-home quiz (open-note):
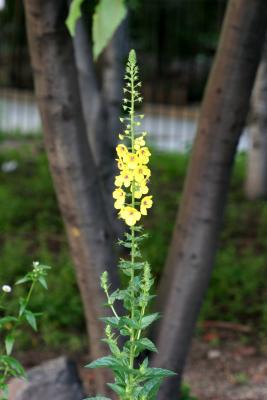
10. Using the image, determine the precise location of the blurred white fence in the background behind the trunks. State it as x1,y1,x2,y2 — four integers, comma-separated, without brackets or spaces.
0,90,249,152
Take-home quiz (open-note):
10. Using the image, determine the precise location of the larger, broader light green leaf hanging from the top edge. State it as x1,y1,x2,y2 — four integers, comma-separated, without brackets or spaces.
93,0,127,60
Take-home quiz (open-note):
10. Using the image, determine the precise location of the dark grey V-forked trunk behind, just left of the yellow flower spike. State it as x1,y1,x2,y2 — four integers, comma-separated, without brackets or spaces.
69,12,128,239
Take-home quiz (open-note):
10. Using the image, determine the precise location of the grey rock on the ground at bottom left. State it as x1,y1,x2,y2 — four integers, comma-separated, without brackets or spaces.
9,357,85,400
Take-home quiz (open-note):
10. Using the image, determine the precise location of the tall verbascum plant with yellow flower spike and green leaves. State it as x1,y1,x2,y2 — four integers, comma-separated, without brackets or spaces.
87,50,174,400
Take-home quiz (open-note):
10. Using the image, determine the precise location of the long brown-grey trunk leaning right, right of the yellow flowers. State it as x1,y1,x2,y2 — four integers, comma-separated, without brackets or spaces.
153,0,267,400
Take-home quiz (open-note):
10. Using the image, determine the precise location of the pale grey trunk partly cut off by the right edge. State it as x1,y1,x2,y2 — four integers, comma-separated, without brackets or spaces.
245,42,267,199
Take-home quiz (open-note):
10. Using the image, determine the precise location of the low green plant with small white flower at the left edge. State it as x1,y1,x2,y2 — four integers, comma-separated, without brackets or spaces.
0,262,50,400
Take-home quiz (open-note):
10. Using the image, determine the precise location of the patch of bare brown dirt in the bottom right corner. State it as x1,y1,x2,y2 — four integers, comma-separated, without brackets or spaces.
185,340,267,400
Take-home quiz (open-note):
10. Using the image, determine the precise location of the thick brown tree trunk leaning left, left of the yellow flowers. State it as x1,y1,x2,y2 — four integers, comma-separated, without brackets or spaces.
24,0,116,394
